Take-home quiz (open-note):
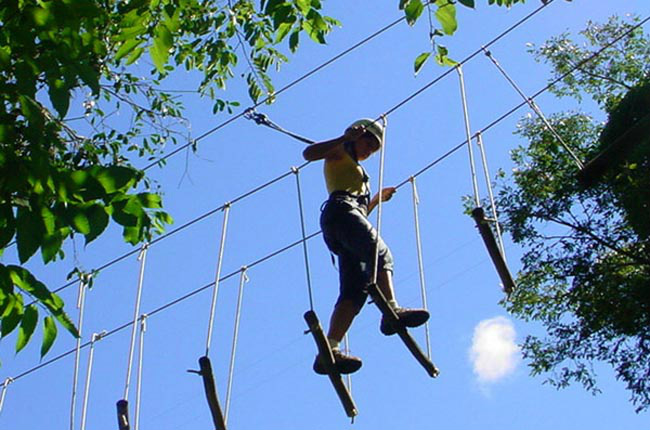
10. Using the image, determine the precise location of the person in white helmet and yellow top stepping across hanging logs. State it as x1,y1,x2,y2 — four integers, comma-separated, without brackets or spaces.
303,119,429,375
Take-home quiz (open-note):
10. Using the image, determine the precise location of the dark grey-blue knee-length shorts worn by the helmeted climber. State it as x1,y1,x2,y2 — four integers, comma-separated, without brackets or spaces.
320,192,393,309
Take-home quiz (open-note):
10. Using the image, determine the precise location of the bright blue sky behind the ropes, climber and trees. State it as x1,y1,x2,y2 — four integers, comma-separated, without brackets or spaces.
0,0,648,430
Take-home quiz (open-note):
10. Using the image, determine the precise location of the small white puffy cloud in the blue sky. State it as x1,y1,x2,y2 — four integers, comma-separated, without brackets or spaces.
469,317,520,383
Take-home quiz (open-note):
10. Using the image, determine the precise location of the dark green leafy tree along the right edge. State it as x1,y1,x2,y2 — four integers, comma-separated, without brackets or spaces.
499,17,650,411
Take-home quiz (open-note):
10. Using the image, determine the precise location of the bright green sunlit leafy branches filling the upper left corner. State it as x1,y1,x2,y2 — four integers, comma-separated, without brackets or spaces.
0,0,338,362
